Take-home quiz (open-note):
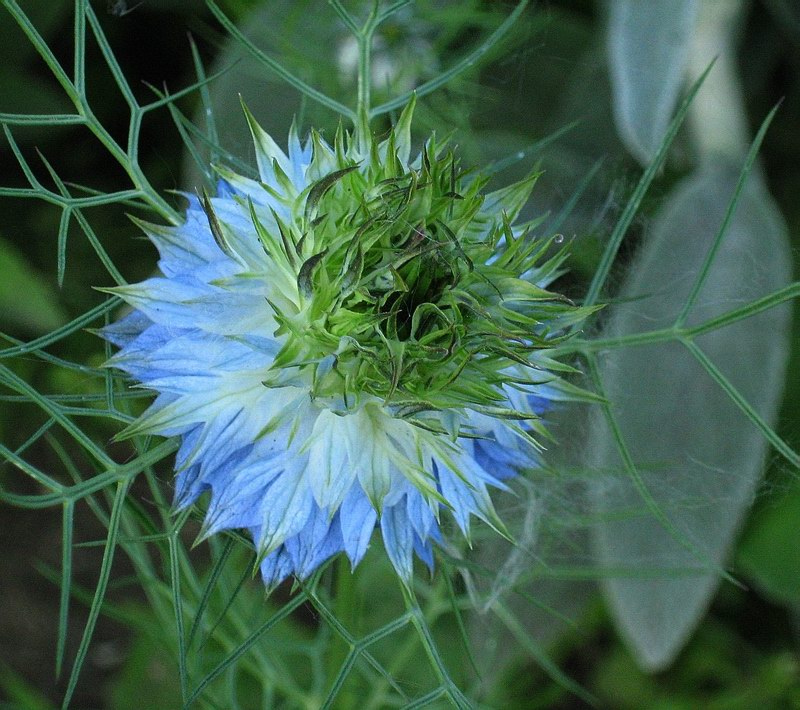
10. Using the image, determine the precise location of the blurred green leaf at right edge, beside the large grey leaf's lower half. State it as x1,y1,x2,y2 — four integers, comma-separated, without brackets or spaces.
737,486,800,607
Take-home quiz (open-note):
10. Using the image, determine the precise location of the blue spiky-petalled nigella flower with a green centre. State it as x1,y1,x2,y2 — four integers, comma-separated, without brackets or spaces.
104,101,585,584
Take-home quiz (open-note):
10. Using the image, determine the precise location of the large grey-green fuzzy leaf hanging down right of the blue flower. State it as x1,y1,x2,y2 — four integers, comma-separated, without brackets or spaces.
588,164,791,670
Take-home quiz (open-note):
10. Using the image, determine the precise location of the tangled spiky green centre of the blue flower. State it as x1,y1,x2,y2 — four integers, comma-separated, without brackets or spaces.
247,129,579,434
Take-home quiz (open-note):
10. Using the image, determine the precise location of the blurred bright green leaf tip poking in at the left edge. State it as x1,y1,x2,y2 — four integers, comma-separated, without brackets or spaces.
0,238,67,335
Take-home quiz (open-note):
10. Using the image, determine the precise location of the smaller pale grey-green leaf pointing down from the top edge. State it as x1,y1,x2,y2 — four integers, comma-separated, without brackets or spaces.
608,0,698,165
